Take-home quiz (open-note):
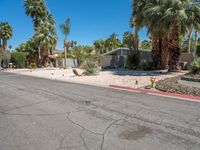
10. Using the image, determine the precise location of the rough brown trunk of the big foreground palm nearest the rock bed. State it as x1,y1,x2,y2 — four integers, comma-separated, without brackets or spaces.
168,24,181,72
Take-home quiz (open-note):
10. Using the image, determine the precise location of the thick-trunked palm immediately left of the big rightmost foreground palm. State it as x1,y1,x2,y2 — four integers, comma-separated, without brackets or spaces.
140,0,169,69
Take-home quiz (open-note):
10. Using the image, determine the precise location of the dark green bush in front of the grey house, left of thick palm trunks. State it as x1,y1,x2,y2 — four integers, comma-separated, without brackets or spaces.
126,53,140,69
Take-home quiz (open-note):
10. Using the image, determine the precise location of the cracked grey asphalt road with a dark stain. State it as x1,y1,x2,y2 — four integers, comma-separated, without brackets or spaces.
0,72,200,150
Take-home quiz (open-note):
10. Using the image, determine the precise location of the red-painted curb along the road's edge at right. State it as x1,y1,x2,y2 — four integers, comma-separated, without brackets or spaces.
110,85,200,102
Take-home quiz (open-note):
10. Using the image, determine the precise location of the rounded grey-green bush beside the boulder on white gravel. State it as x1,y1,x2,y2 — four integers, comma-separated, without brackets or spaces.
82,60,100,75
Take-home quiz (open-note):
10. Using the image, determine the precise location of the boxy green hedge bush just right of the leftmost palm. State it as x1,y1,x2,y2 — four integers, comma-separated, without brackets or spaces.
12,52,26,68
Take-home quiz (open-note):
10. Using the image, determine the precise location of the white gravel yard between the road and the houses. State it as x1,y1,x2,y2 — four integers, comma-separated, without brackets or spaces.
6,68,186,88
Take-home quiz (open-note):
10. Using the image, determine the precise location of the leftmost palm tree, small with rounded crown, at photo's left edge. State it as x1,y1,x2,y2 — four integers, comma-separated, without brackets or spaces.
0,22,13,52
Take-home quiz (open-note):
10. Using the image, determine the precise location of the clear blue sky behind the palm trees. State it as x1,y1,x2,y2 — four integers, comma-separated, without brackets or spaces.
0,0,147,49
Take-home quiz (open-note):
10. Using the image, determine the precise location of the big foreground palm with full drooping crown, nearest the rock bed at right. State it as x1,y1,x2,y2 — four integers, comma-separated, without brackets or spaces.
162,0,200,71
